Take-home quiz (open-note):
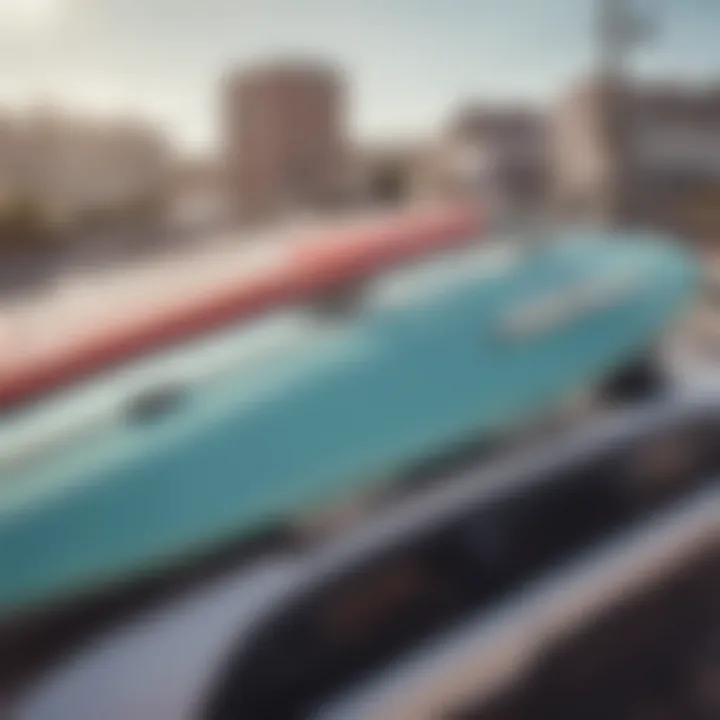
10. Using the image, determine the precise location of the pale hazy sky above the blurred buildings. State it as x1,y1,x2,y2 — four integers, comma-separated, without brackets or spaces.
0,0,720,150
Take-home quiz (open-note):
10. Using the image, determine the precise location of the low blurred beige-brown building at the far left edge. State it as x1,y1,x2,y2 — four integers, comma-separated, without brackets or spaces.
0,109,171,231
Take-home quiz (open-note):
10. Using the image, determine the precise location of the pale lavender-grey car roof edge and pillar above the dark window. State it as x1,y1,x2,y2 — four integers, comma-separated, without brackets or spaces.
11,395,720,720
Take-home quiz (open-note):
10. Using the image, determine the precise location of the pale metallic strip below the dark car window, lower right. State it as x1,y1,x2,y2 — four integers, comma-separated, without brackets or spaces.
318,485,720,720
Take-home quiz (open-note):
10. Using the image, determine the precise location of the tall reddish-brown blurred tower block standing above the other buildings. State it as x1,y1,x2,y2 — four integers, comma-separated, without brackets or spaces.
224,61,347,222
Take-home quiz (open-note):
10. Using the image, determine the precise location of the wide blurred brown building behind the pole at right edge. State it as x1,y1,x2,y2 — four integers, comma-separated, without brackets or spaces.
553,81,720,238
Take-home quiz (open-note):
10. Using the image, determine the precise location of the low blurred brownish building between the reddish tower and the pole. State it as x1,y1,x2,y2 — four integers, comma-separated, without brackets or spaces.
414,105,549,214
